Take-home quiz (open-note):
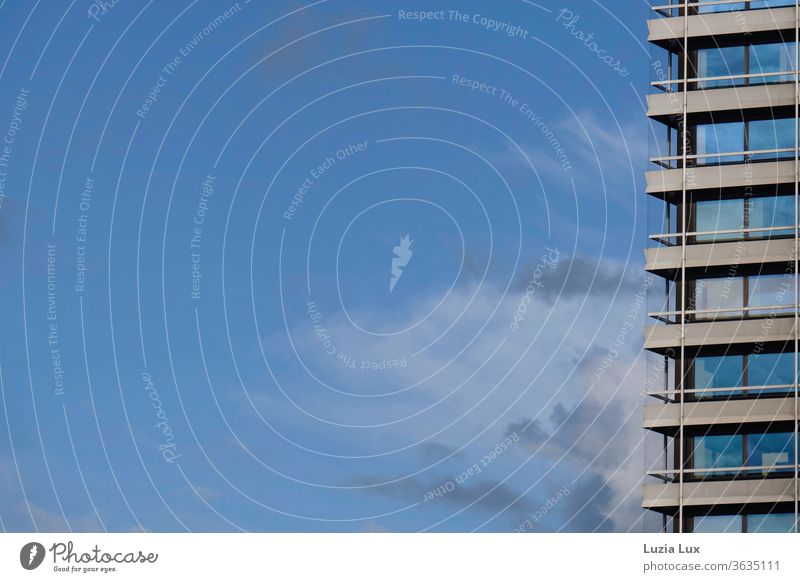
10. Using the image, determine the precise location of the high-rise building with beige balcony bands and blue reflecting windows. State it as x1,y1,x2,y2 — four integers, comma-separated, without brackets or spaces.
643,0,800,532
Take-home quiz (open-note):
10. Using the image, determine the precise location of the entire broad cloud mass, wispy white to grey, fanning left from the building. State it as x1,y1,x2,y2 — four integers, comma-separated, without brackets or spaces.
262,251,645,531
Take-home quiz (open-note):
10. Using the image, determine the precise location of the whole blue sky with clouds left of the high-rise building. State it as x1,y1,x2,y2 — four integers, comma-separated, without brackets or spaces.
0,0,649,531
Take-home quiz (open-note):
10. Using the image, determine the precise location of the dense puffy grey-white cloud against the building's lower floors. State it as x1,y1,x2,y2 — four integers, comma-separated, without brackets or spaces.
506,350,645,531
